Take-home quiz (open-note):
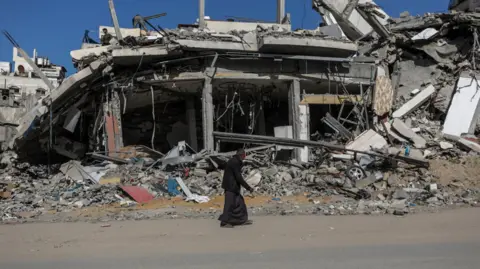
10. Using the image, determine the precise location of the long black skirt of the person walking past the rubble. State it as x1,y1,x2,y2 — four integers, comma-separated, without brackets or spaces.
218,191,248,225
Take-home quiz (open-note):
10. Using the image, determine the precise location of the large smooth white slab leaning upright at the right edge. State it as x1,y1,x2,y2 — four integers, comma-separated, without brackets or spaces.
443,72,480,136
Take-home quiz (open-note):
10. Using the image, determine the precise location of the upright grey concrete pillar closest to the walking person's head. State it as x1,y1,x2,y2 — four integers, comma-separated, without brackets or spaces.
202,78,214,151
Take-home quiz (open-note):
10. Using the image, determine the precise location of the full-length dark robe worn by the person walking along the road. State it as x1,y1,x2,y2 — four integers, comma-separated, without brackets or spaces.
218,156,252,225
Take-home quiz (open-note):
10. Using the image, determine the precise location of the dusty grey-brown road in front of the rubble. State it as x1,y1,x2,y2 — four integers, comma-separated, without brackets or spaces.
0,208,480,269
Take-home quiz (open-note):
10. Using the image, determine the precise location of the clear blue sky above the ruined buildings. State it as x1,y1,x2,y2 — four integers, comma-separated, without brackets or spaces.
0,0,449,74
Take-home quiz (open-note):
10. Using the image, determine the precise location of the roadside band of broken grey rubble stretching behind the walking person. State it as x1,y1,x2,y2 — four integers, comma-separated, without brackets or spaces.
0,137,480,221
